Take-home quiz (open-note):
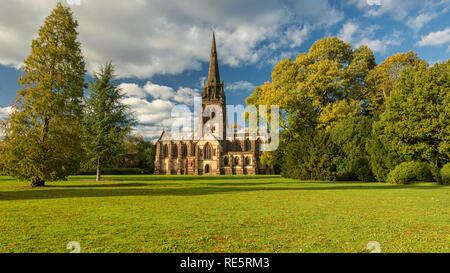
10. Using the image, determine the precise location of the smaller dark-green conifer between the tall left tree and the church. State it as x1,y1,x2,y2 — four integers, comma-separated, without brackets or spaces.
84,63,135,181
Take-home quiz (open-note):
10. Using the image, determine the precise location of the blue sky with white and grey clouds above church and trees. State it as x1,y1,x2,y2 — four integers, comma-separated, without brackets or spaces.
0,0,450,139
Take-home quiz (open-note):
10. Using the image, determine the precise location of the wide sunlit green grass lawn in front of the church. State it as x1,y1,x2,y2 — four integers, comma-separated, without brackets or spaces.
0,176,450,253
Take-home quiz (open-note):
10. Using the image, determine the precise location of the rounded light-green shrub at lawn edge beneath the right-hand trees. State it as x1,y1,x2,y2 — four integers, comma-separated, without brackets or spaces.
387,161,433,184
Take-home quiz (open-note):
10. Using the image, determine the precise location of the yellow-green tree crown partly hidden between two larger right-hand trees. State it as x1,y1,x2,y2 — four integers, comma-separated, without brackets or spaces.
365,51,428,114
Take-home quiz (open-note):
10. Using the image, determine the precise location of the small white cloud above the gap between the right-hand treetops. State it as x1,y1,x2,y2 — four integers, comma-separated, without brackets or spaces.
338,21,402,54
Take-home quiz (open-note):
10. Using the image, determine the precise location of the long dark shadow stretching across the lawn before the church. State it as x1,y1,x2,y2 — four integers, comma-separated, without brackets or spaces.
0,183,442,201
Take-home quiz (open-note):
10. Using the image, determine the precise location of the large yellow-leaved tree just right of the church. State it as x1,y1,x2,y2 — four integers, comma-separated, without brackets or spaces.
246,37,376,172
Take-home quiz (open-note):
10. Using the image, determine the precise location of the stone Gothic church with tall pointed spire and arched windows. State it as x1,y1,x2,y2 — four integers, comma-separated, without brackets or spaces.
155,34,274,175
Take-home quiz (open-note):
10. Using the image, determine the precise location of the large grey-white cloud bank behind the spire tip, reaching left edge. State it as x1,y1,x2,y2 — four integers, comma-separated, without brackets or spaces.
0,0,343,78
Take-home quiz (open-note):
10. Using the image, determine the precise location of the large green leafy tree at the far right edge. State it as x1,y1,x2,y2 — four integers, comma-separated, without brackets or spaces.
376,60,450,169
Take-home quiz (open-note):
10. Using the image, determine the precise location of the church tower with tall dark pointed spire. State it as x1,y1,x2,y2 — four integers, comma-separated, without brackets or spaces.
199,33,227,140
